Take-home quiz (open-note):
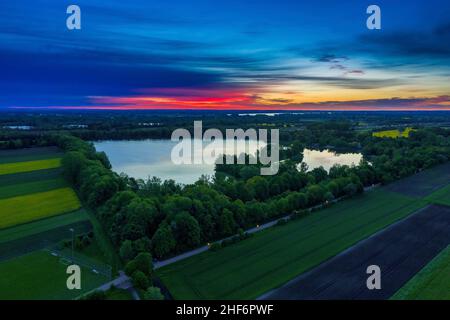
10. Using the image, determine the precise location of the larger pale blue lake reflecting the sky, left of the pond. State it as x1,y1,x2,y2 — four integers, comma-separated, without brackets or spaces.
94,139,264,184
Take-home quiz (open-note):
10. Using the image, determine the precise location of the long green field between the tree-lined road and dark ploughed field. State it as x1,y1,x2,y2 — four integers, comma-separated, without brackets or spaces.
157,189,426,299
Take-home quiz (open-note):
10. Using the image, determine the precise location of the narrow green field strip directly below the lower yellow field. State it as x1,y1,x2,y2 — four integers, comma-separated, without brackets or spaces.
0,209,89,243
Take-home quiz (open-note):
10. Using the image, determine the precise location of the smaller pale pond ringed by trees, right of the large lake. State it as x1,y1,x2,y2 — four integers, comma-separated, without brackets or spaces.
298,149,363,171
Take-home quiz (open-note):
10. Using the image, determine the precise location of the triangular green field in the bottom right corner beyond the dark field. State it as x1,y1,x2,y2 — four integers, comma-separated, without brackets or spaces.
391,246,450,300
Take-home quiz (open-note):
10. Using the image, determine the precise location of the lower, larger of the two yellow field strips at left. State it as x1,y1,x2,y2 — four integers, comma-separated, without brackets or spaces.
0,188,80,229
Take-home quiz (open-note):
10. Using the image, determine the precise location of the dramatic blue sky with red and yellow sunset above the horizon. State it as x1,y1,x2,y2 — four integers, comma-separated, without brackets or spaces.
0,0,450,110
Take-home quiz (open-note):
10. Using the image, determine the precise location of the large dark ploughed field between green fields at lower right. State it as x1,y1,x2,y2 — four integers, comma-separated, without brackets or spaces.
259,205,450,300
